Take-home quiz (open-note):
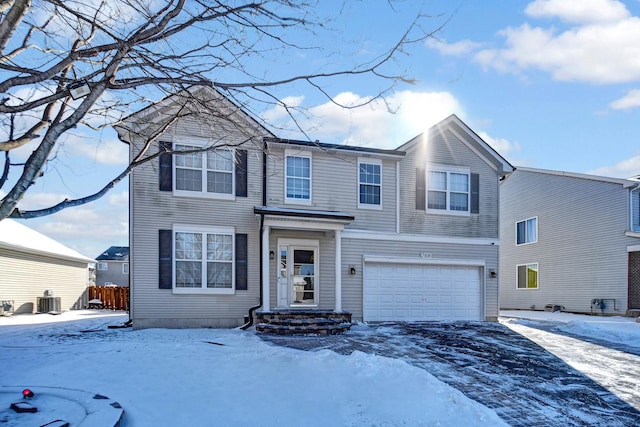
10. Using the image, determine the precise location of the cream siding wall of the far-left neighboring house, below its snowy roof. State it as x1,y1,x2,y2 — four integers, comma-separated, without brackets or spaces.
0,248,89,313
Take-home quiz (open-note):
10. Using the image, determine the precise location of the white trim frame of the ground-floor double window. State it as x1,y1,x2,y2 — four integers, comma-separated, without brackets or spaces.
171,224,236,295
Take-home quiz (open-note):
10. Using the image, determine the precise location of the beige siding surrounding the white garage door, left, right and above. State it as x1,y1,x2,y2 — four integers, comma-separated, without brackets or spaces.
342,236,498,320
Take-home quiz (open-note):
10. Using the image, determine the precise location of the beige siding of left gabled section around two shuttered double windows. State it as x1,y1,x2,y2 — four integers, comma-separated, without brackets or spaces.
130,113,262,328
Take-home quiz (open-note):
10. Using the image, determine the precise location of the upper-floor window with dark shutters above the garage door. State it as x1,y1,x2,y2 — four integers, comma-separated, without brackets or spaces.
427,167,470,214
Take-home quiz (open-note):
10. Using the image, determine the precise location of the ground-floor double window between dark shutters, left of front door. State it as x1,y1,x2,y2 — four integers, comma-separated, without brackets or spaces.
174,227,234,293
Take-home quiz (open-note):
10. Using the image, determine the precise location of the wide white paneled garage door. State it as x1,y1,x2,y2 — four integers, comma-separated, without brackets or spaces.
364,263,482,321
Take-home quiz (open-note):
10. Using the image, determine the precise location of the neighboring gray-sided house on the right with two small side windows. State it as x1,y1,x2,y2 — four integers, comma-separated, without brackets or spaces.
499,168,640,315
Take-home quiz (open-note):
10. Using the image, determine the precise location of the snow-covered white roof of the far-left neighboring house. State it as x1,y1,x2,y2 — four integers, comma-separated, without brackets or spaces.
0,219,94,263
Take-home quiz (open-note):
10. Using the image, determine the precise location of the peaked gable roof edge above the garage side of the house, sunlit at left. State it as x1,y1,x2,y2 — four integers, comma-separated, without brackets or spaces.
397,114,515,175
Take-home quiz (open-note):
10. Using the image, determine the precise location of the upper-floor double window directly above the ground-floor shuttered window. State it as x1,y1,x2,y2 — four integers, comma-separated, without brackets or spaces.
174,144,234,197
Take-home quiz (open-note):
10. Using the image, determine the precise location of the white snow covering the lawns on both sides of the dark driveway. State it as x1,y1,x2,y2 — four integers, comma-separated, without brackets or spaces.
0,310,640,427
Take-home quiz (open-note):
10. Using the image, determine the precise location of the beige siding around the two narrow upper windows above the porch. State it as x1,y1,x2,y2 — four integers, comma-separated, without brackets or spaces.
267,144,396,231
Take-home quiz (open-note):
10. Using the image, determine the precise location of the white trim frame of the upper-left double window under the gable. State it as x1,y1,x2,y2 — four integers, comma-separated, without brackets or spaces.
171,138,236,200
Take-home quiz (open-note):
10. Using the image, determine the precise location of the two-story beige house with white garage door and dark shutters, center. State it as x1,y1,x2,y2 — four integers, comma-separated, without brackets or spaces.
118,89,513,328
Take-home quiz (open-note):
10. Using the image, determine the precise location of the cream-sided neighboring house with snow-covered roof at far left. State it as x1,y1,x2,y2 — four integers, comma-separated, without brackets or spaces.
0,219,95,313
